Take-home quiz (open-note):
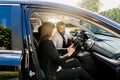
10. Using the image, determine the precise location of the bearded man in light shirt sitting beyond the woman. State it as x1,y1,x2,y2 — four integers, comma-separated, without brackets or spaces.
53,21,72,48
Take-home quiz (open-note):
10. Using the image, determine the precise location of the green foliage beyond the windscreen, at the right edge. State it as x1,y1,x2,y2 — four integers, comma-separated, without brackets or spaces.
100,7,120,23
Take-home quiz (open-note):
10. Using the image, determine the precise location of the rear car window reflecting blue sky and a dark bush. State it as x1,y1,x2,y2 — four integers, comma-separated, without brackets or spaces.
0,6,11,50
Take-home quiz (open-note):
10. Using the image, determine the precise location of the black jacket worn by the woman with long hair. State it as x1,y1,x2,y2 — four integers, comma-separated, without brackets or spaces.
38,39,69,80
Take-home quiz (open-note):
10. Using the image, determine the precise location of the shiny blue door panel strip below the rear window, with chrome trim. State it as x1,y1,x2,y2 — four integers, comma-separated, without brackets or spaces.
0,50,22,66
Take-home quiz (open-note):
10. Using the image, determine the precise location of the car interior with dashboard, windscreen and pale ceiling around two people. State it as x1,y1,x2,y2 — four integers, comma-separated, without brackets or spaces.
30,11,120,80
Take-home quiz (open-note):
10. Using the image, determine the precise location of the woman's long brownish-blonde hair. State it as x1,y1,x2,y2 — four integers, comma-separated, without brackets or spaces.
38,22,55,44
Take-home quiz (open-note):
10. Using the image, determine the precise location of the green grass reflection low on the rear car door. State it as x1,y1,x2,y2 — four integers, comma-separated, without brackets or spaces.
0,71,19,80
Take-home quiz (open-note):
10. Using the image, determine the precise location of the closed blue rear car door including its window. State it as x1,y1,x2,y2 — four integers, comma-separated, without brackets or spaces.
0,3,22,79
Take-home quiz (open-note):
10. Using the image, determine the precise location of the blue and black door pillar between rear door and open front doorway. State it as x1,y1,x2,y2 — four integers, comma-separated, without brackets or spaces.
20,5,45,80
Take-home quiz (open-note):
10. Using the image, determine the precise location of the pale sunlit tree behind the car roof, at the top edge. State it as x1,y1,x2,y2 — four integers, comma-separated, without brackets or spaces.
77,0,103,13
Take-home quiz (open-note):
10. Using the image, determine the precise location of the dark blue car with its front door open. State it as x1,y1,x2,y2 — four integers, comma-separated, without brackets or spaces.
0,0,120,80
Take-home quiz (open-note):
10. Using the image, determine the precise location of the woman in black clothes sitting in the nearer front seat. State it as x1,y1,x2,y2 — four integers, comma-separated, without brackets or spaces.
38,22,93,80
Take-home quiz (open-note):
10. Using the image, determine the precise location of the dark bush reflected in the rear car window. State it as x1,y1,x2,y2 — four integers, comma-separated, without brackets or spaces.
0,25,11,49
